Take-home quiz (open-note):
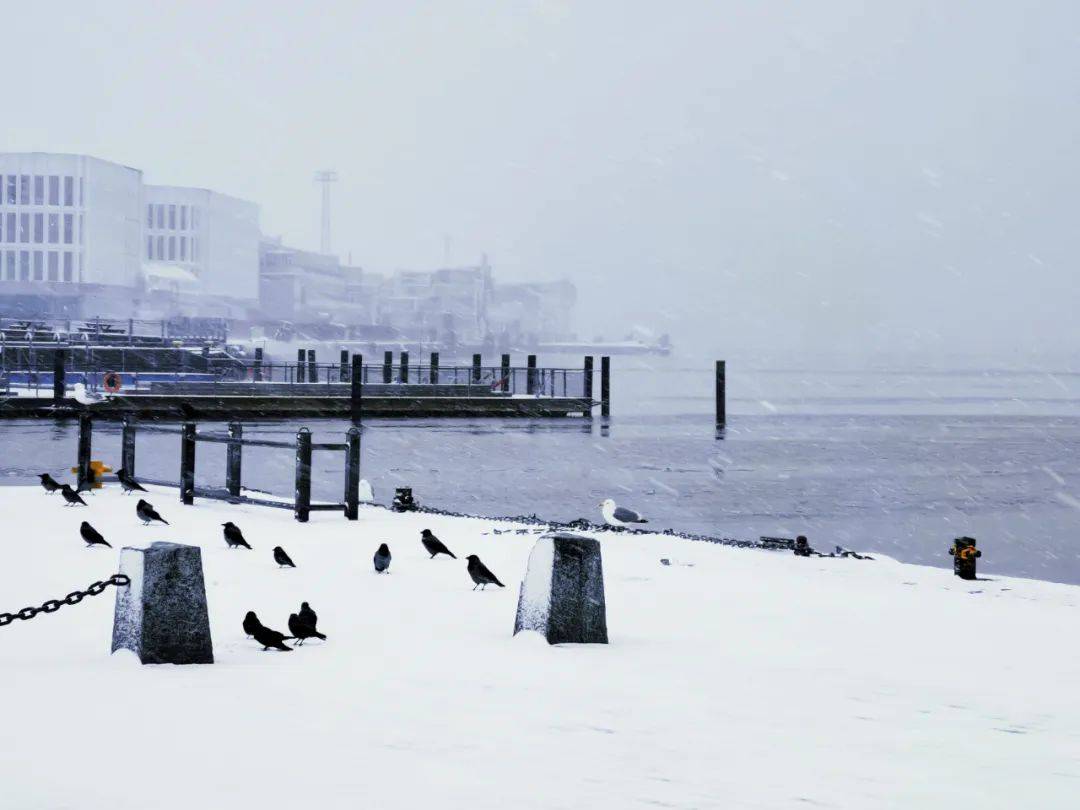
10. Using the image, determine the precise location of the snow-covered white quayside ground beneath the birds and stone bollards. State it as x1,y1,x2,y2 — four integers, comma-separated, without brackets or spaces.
0,485,1080,810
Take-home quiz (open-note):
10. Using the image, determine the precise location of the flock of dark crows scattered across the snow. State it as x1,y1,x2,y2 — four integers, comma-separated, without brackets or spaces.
38,468,505,651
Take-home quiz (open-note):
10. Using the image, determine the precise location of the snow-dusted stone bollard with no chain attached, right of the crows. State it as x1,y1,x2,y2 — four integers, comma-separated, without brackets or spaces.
514,531,608,644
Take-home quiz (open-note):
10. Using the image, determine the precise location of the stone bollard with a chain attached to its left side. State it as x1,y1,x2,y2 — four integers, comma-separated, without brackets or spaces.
112,542,214,664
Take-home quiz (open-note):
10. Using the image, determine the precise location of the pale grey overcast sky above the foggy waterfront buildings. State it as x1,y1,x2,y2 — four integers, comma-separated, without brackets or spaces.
8,0,1080,356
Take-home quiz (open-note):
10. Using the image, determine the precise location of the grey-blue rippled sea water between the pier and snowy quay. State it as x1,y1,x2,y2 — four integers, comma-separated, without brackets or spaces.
0,357,1080,582
